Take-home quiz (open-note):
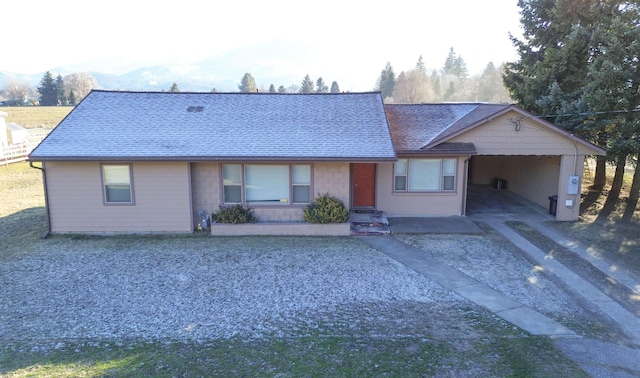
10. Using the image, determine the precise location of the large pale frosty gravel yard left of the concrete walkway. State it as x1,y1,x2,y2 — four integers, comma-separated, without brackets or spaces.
0,236,465,341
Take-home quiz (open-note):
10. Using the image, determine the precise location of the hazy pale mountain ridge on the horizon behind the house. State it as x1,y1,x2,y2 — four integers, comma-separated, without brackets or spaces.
0,41,358,92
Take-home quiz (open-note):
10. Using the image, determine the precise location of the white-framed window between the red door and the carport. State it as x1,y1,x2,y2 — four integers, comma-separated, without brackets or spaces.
393,159,456,192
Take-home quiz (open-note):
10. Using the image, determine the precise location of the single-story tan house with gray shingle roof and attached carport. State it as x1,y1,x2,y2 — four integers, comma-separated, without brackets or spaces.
29,90,605,233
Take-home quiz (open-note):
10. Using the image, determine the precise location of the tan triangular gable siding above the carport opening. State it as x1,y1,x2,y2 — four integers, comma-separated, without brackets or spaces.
450,113,575,155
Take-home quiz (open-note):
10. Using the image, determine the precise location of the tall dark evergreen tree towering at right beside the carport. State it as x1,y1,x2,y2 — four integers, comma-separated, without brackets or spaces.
503,0,640,211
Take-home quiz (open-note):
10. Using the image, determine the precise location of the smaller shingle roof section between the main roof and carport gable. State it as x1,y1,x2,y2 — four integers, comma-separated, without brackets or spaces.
385,104,510,153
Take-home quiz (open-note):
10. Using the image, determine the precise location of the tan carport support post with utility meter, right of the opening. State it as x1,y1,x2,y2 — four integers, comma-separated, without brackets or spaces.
556,155,584,221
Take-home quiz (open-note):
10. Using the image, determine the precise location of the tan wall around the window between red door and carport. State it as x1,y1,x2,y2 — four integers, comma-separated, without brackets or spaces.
376,156,466,216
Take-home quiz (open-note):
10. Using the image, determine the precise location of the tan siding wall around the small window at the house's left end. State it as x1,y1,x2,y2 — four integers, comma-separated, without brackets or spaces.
45,162,193,233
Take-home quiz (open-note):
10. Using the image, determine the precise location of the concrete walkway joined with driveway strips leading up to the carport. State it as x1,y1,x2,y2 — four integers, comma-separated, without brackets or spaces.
359,191,640,377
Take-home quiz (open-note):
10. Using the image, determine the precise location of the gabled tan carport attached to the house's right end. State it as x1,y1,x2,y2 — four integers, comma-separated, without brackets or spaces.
448,107,605,221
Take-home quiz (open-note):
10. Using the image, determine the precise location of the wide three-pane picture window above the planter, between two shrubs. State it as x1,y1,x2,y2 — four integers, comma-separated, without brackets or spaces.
222,164,311,206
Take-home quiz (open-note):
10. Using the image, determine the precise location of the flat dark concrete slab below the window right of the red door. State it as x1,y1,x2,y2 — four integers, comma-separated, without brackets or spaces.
389,217,484,234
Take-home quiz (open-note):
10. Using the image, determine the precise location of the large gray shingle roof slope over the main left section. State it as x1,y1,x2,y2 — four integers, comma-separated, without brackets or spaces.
30,91,396,161
